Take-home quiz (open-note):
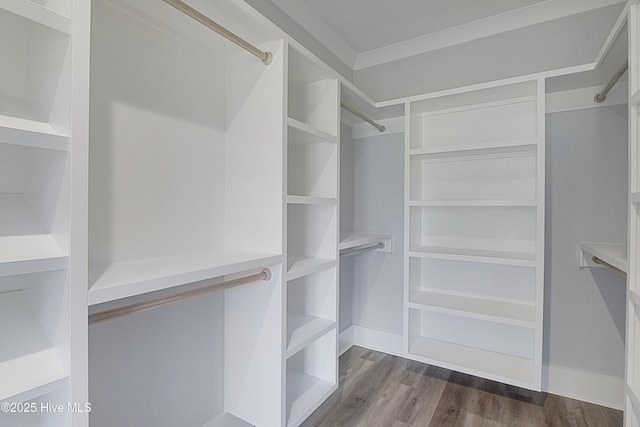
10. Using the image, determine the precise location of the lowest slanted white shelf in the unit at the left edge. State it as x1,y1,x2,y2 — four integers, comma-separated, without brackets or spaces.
0,291,67,401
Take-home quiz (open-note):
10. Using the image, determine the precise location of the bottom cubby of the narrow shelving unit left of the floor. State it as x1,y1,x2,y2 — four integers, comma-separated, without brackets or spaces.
286,329,337,426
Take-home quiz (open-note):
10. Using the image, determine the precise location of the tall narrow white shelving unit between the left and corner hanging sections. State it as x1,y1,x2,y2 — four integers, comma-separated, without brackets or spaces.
283,47,340,426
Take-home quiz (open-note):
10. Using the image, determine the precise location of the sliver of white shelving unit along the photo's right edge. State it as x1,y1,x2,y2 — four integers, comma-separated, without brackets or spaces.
624,1,640,427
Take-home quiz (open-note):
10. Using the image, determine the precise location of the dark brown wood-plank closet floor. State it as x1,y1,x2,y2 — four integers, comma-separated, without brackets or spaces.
302,347,622,427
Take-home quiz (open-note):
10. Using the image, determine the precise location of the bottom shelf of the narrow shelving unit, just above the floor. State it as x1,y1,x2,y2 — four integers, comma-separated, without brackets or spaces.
287,372,338,426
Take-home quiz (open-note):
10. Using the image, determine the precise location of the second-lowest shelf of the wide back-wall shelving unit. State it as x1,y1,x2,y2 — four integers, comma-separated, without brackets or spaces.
409,289,536,328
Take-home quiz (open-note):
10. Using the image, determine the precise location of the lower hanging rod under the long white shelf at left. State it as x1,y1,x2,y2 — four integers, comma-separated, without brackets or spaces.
89,268,271,323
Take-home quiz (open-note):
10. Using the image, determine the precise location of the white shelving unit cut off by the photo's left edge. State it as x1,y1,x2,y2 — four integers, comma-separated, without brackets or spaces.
0,0,72,426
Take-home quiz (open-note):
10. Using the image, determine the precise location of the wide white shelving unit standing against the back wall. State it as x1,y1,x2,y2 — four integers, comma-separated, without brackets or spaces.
405,80,545,390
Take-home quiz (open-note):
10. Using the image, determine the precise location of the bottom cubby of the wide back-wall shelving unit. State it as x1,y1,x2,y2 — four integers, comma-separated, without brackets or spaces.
409,308,535,388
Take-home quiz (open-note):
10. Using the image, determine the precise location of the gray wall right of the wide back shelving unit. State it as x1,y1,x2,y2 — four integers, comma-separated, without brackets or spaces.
543,105,627,378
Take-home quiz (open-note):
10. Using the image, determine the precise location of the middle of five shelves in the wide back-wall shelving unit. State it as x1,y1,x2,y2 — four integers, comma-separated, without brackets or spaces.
409,246,536,267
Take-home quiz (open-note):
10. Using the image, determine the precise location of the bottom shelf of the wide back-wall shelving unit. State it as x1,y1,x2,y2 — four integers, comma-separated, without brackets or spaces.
409,336,534,386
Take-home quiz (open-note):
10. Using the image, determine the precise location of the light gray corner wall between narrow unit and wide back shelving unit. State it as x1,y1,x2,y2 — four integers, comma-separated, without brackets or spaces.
340,125,404,334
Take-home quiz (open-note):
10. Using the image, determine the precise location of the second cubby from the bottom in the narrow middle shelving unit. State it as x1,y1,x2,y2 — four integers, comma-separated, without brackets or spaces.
286,268,337,357
